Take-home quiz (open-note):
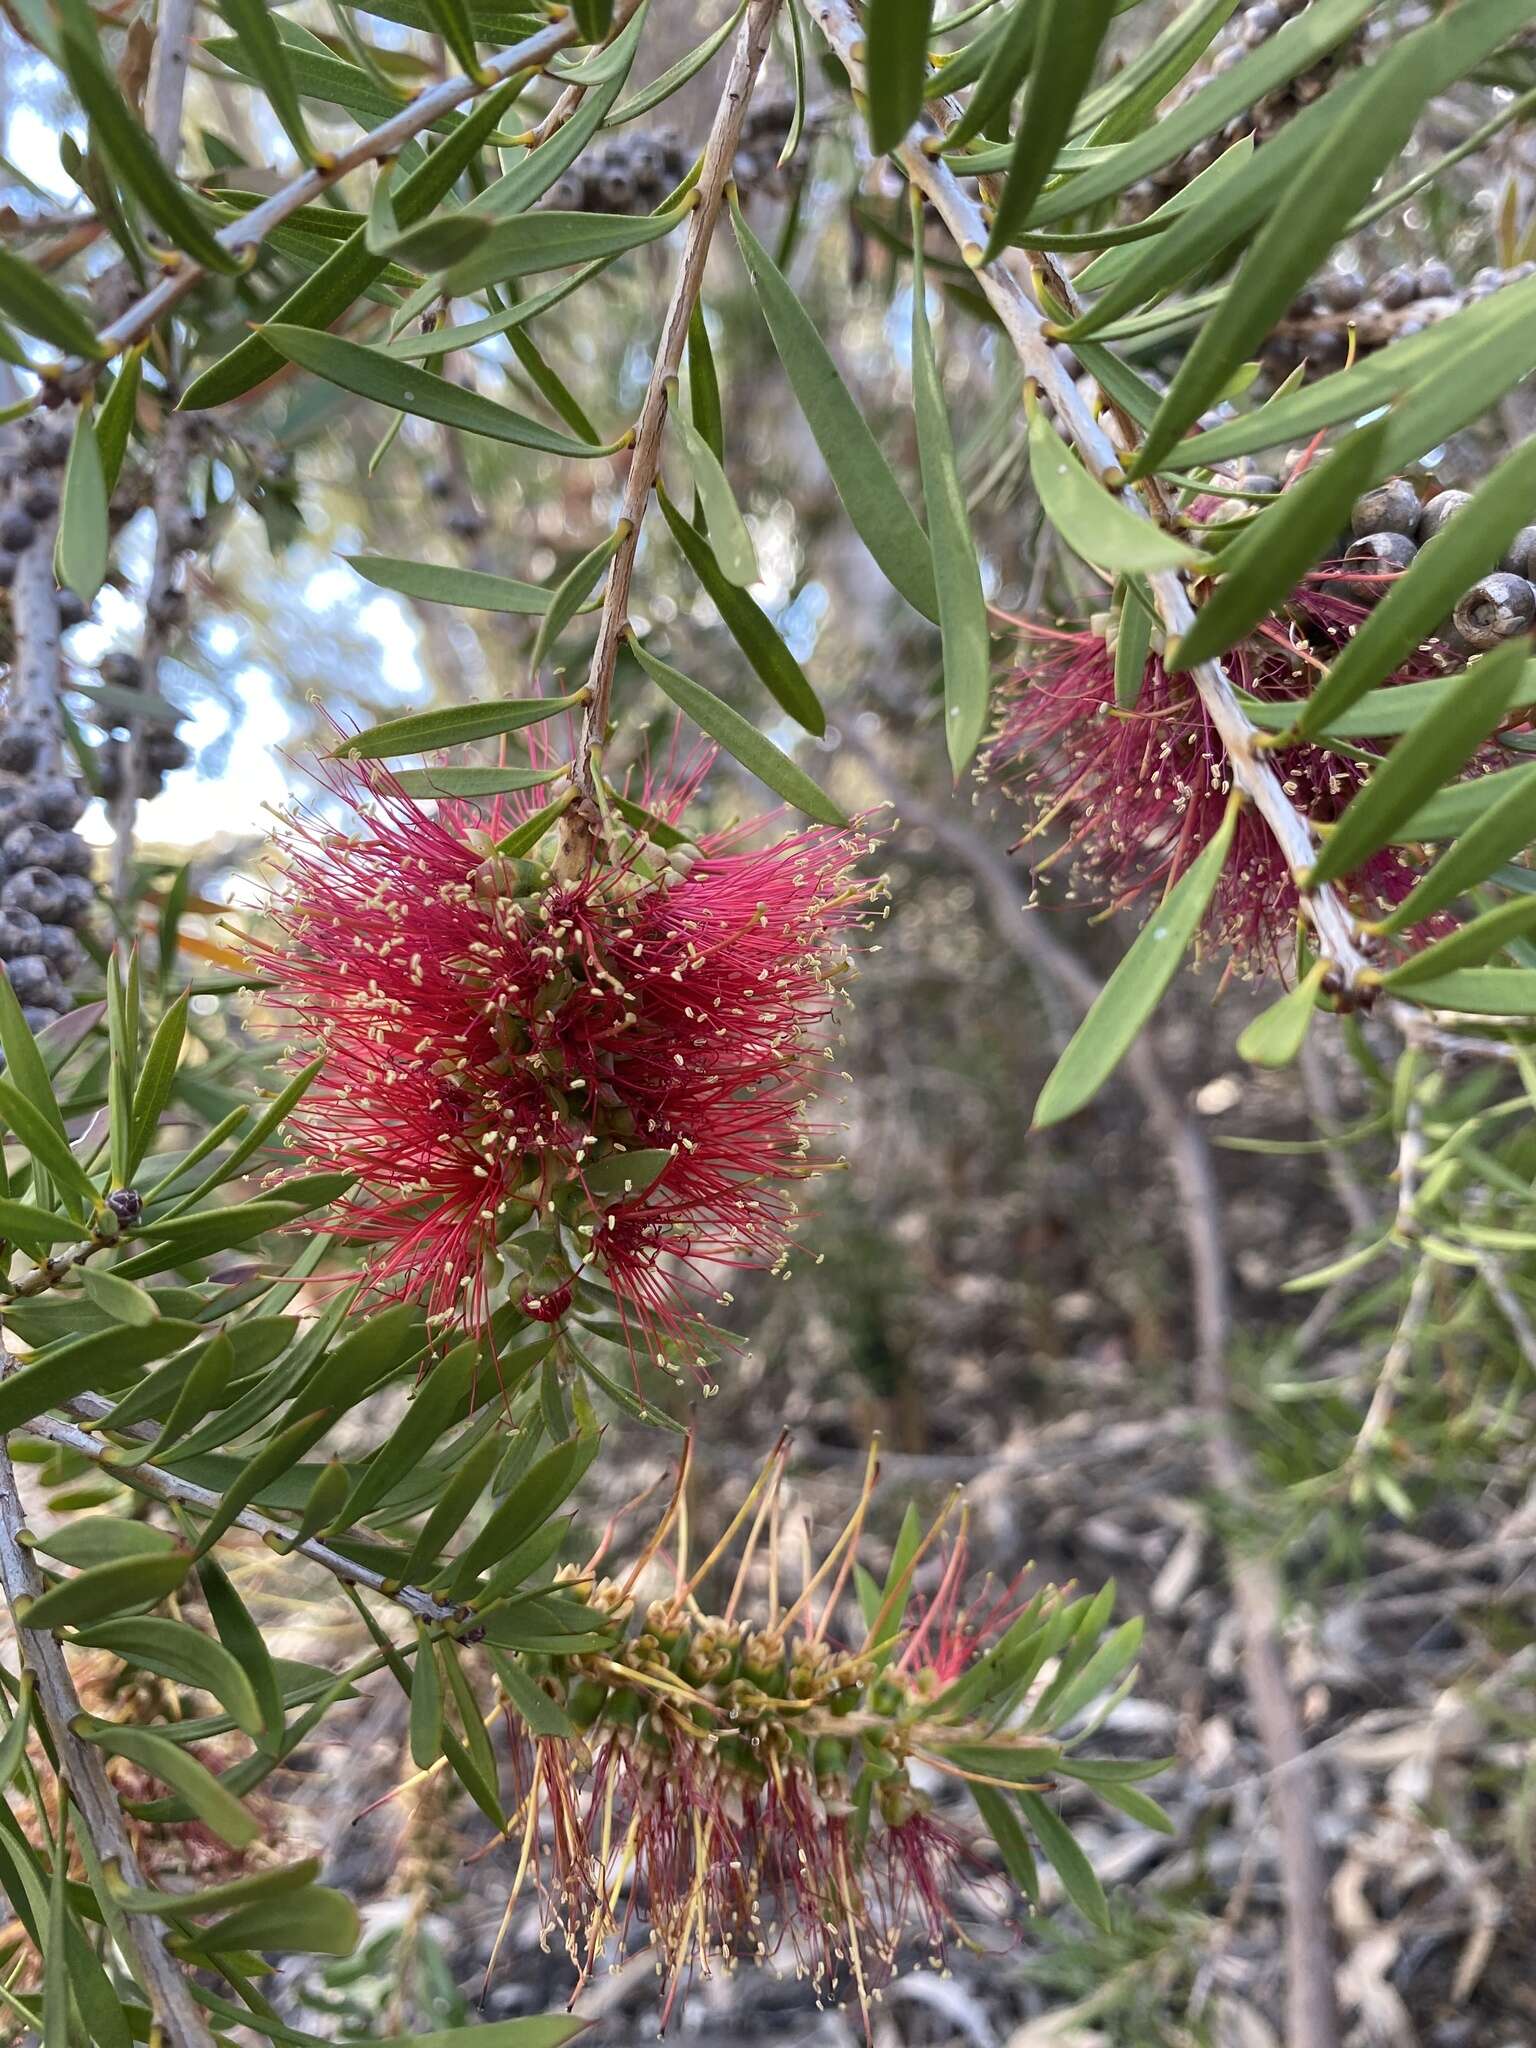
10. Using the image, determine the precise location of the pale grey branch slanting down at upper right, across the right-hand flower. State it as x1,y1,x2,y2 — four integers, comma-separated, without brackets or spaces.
807,0,1368,991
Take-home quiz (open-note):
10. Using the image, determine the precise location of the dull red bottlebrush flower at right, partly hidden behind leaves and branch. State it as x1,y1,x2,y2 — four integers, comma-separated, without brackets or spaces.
987,563,1482,969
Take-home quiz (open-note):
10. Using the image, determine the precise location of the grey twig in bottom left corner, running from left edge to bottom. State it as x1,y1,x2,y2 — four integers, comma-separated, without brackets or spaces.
0,1444,213,2048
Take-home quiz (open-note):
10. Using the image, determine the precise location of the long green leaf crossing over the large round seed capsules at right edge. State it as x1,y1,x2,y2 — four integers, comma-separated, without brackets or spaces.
1294,440,1536,733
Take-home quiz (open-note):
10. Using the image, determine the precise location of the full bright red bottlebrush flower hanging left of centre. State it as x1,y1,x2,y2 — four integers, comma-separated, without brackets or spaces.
254,762,870,1370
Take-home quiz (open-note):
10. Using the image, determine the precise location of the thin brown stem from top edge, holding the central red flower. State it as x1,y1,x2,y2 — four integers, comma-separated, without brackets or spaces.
578,0,778,797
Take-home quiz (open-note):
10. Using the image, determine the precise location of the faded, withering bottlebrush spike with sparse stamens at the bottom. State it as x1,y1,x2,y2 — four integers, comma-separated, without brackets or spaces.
487,1444,1155,2025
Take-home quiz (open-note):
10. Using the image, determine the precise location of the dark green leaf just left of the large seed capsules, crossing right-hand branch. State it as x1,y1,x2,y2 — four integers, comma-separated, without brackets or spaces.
1163,420,1386,674
